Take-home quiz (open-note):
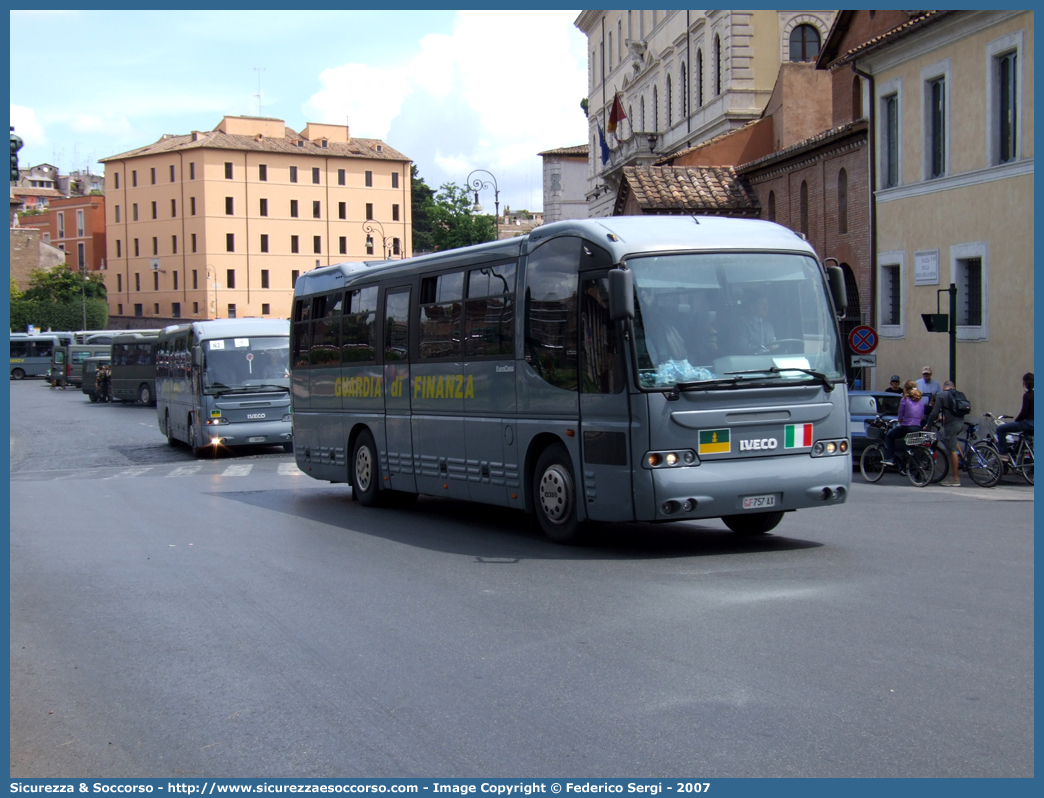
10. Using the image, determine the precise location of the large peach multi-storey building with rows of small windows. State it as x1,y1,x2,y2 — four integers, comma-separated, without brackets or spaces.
101,116,412,327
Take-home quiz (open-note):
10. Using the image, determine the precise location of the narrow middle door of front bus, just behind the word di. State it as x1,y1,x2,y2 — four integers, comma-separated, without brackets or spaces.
384,286,418,493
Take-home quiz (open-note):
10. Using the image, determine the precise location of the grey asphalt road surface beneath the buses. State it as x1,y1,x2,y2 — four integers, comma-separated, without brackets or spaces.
10,381,1034,778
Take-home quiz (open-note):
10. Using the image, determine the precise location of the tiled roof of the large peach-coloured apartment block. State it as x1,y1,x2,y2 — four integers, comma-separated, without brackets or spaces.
100,127,410,163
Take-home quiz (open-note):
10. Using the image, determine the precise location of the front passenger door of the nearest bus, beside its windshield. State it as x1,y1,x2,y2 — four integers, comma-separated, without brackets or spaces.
576,274,640,521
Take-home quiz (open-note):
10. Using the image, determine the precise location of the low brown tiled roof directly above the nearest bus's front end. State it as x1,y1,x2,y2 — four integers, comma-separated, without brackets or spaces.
621,166,760,213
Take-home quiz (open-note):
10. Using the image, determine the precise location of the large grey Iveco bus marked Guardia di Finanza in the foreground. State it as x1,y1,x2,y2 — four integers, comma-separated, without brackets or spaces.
290,216,852,543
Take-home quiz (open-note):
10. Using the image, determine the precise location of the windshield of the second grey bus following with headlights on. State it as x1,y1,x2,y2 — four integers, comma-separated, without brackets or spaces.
203,337,290,394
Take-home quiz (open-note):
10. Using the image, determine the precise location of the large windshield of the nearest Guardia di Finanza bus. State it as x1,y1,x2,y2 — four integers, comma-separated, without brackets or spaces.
627,252,844,389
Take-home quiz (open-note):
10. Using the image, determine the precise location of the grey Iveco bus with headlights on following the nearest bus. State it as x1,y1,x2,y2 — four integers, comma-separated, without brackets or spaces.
156,319,293,454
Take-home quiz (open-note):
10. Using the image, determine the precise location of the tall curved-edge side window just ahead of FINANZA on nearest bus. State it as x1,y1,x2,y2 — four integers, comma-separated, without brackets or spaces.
524,237,580,391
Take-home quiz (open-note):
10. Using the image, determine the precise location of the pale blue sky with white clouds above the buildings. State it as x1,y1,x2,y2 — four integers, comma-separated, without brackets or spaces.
10,10,587,211
